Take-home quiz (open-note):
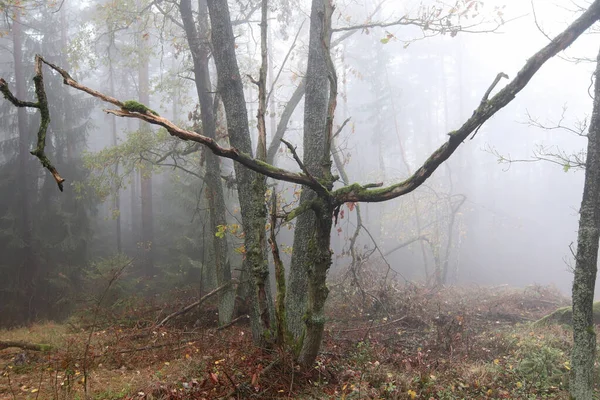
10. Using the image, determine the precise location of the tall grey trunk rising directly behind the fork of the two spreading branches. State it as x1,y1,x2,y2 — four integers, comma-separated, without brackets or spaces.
286,0,329,339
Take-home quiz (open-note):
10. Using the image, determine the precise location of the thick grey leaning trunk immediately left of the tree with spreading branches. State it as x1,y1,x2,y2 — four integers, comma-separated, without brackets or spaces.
207,0,274,344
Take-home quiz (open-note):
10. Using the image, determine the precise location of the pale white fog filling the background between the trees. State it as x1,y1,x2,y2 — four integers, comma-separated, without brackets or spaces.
0,0,598,324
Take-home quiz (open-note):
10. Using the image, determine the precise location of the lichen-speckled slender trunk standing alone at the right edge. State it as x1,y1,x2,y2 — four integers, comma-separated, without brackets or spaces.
570,45,600,400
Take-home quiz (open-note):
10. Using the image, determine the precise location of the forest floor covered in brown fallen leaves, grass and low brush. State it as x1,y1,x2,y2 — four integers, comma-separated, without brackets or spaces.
0,276,592,400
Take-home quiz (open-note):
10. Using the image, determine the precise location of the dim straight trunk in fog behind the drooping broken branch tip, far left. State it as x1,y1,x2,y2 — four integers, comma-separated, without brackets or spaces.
12,11,39,322
